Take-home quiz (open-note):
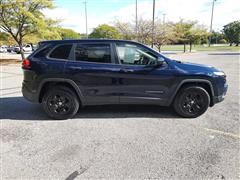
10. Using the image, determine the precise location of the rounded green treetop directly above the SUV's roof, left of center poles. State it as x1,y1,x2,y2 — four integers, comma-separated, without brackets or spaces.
89,24,121,39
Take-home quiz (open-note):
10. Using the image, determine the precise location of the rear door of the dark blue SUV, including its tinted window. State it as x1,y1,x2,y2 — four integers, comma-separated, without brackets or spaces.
65,43,119,105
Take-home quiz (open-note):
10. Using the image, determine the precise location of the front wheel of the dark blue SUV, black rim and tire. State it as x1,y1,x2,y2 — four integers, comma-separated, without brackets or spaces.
173,86,210,118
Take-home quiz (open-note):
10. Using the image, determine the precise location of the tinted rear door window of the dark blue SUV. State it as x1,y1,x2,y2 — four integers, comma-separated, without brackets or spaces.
75,44,111,63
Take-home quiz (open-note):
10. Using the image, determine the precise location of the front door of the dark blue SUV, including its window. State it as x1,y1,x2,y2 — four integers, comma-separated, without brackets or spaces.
116,42,174,105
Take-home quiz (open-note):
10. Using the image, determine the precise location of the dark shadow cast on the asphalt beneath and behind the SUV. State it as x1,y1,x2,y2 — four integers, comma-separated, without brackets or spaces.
0,97,179,121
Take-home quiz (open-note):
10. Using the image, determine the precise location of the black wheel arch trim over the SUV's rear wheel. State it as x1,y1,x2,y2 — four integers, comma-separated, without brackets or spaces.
38,78,84,105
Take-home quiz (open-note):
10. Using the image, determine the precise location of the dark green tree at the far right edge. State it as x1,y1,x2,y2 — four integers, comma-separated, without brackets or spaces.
223,21,240,46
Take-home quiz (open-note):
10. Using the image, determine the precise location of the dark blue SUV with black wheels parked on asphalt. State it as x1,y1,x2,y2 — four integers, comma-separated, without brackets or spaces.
22,39,227,119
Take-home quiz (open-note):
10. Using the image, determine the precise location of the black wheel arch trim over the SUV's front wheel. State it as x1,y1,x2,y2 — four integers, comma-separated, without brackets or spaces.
169,79,214,107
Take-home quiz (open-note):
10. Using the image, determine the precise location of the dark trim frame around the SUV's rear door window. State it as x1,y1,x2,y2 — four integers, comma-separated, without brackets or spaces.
71,42,117,65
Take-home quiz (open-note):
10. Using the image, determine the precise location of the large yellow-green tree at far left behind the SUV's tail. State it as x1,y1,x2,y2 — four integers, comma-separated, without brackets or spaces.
0,0,53,59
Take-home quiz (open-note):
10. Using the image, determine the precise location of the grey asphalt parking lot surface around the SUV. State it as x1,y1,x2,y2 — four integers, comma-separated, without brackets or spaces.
0,52,240,180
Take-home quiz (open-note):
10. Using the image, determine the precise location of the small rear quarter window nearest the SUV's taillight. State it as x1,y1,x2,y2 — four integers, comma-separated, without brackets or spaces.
49,44,72,59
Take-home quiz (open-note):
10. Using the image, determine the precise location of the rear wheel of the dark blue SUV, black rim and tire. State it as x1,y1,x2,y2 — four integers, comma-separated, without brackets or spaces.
42,86,79,120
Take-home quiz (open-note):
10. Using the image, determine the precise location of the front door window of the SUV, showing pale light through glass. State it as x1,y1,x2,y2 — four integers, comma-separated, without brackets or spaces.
116,43,157,65
